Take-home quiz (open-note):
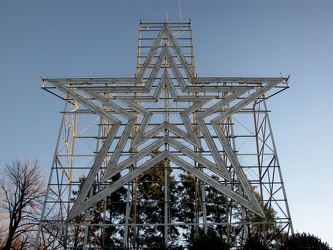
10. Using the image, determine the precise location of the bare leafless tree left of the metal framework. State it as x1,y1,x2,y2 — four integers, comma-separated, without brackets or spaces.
0,160,46,250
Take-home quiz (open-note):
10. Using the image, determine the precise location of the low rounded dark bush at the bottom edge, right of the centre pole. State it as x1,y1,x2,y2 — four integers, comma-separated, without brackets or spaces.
188,229,230,250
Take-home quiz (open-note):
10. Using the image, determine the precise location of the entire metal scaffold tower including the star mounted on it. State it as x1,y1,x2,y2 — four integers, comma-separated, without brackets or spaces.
36,21,292,249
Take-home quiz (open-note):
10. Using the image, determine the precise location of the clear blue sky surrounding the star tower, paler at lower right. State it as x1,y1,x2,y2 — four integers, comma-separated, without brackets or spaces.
0,0,333,247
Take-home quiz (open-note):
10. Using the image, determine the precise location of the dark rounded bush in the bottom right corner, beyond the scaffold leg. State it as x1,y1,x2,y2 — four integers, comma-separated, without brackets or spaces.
280,233,332,250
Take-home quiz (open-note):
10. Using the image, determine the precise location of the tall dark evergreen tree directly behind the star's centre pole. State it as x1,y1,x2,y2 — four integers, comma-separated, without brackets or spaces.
135,151,179,249
